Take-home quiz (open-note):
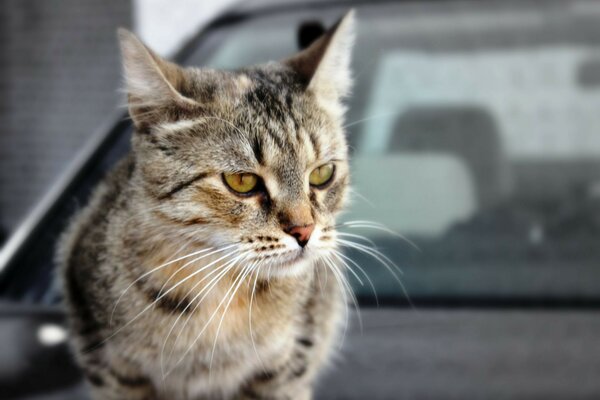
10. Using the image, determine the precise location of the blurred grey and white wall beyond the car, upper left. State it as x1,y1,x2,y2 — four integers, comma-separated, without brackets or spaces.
0,0,233,240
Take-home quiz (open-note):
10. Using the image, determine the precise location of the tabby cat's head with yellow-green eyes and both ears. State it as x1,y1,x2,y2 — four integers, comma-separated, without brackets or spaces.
120,11,353,275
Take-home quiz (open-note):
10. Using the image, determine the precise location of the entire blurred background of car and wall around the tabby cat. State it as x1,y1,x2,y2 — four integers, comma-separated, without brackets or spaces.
0,0,600,399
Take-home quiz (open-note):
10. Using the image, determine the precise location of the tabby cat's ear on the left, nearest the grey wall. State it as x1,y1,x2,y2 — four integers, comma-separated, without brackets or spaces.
118,28,198,128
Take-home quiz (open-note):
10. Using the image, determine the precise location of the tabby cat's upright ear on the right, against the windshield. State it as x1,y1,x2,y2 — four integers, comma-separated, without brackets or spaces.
283,9,354,107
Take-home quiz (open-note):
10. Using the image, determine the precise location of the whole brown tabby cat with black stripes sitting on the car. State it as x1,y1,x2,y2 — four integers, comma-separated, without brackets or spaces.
57,11,354,400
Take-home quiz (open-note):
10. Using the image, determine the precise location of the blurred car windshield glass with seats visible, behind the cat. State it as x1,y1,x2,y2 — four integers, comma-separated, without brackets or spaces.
190,3,600,302
